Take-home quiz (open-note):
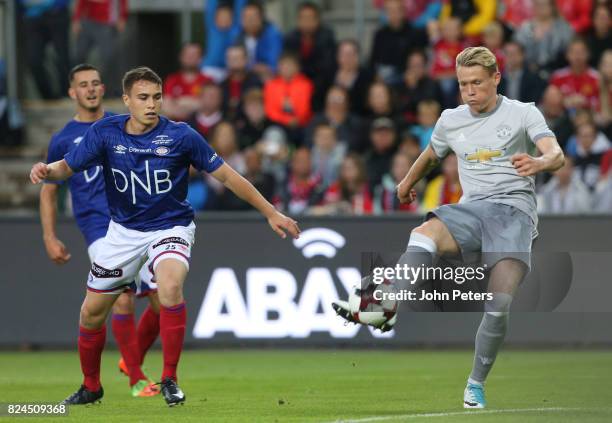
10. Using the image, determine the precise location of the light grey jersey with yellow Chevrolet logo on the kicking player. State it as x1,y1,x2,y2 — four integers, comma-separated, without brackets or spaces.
431,95,555,236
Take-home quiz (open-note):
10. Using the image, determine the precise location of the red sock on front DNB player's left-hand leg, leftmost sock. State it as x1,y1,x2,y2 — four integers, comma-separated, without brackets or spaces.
78,325,106,392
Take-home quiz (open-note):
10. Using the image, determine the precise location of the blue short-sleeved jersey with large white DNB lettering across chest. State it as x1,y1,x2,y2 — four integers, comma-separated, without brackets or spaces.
64,115,223,232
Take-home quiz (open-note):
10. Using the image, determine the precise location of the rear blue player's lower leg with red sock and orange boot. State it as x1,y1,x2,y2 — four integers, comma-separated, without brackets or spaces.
112,292,159,397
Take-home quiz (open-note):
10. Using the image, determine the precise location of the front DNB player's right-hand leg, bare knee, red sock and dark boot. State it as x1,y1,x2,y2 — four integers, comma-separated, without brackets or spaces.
155,257,187,406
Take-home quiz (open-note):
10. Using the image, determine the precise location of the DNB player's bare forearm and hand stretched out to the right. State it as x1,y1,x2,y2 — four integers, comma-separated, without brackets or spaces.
211,163,300,239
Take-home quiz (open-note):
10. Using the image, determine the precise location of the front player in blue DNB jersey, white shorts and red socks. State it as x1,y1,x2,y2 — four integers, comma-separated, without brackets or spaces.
30,67,300,406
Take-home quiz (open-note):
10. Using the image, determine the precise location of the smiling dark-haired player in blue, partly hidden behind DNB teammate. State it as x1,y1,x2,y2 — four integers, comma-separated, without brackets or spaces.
40,64,159,397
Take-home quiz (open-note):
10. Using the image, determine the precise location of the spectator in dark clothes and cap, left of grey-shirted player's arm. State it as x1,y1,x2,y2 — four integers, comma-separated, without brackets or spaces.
365,117,397,191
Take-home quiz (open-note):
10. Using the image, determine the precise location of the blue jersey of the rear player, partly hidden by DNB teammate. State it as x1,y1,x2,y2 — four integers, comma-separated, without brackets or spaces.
47,113,112,245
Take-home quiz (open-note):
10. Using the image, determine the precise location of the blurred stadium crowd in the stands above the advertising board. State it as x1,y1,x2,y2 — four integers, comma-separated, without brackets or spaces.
13,0,612,215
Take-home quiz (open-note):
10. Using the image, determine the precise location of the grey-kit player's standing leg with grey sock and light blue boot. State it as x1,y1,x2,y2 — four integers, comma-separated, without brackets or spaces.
463,259,527,408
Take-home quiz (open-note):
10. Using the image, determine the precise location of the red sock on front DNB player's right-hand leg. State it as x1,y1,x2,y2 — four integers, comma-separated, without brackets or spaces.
159,302,187,380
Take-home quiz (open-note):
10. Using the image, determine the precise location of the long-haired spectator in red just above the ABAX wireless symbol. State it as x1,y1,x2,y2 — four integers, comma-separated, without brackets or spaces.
318,153,373,215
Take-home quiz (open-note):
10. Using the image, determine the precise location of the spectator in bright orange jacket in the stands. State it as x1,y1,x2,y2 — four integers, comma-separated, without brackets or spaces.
264,53,313,137
